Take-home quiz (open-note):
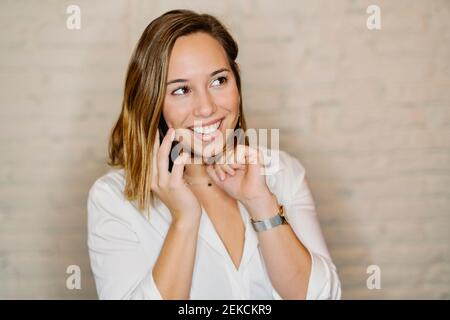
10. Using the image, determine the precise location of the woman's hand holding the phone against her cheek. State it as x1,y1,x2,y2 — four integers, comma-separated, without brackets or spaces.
151,128,202,223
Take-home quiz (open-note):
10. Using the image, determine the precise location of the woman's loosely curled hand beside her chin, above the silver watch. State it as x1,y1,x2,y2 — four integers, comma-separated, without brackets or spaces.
206,145,273,205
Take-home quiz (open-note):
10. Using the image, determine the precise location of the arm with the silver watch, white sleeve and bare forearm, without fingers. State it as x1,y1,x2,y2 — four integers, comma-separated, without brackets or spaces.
246,156,341,299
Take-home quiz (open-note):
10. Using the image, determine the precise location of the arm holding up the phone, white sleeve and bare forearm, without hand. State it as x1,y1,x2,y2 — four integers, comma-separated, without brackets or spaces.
87,182,198,300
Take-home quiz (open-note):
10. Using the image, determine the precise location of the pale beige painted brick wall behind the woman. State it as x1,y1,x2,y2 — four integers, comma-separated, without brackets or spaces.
0,0,450,299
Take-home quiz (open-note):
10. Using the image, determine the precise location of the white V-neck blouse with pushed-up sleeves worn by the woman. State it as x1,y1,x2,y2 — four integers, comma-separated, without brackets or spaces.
87,149,341,300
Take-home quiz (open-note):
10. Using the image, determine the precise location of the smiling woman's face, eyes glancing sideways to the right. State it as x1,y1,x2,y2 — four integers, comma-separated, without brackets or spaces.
163,33,240,158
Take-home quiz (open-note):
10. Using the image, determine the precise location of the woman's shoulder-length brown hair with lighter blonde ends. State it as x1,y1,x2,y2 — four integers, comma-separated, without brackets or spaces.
108,10,247,213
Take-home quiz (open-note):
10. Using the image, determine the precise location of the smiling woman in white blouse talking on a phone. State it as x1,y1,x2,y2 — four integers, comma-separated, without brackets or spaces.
88,10,341,299
